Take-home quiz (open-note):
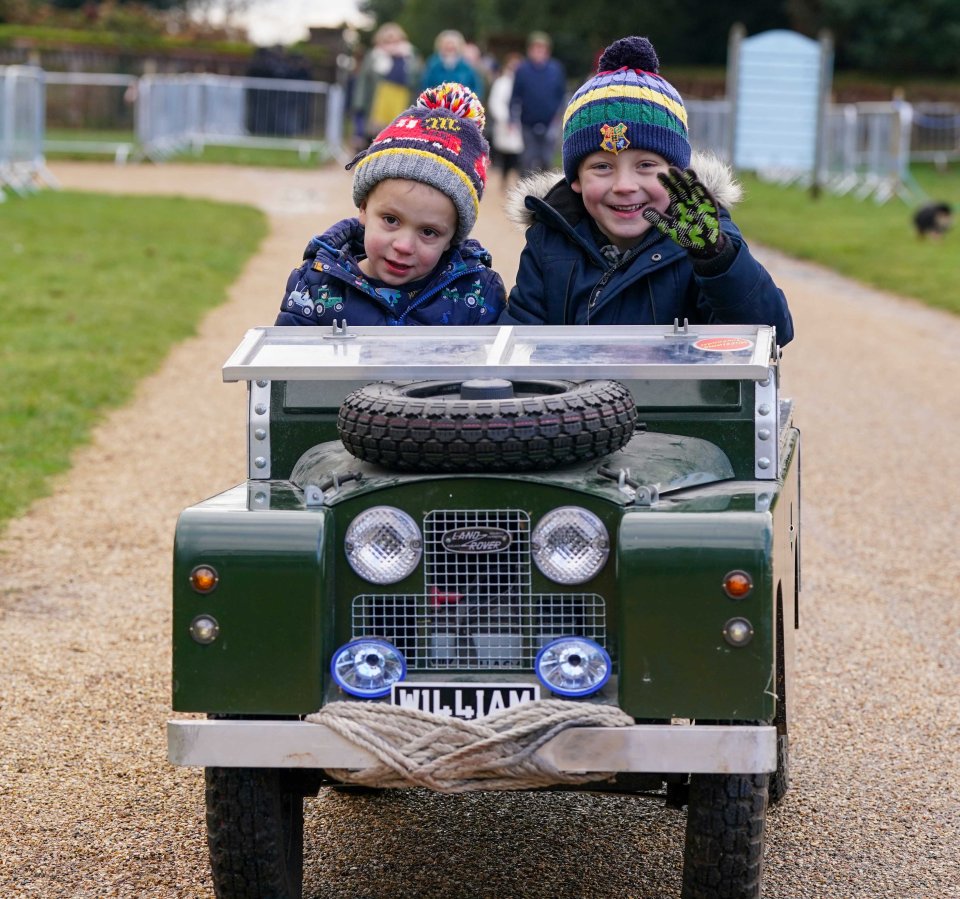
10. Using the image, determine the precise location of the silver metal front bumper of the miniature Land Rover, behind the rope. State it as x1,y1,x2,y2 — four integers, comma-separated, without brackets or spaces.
167,720,777,774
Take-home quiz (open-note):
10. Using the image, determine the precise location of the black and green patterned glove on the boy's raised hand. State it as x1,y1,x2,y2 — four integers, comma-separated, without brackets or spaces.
643,166,724,259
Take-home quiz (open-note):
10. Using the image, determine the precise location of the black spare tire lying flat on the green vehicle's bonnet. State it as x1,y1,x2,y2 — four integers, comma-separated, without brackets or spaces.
337,380,637,472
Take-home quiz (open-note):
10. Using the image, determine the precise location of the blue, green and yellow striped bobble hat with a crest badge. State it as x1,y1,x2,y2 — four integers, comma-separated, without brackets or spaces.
563,37,690,184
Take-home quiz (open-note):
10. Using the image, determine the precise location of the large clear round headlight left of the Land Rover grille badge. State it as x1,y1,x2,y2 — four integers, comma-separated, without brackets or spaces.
343,506,423,584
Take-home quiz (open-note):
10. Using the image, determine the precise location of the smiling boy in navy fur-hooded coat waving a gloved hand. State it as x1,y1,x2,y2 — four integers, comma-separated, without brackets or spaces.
499,37,793,346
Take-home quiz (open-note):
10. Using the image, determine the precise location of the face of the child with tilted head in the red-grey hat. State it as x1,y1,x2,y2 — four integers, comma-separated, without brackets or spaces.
360,178,457,285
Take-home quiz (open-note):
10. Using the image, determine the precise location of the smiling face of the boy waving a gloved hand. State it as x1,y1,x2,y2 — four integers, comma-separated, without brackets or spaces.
571,150,670,250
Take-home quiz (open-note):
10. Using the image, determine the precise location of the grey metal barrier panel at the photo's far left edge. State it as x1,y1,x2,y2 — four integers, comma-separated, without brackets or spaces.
0,66,53,200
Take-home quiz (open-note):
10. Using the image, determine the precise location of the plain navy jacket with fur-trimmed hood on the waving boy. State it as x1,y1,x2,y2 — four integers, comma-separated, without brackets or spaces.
499,153,793,346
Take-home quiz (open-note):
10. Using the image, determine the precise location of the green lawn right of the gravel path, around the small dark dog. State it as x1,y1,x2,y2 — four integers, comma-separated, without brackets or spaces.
734,166,960,313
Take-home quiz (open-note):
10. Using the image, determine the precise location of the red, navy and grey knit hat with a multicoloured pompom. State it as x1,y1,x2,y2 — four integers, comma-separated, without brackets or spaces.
347,81,490,243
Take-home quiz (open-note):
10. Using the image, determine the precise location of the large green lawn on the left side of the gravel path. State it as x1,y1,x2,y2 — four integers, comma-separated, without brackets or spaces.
0,191,266,529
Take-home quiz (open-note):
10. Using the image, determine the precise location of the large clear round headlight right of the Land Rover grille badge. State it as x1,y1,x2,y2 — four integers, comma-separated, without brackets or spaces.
531,506,610,584
